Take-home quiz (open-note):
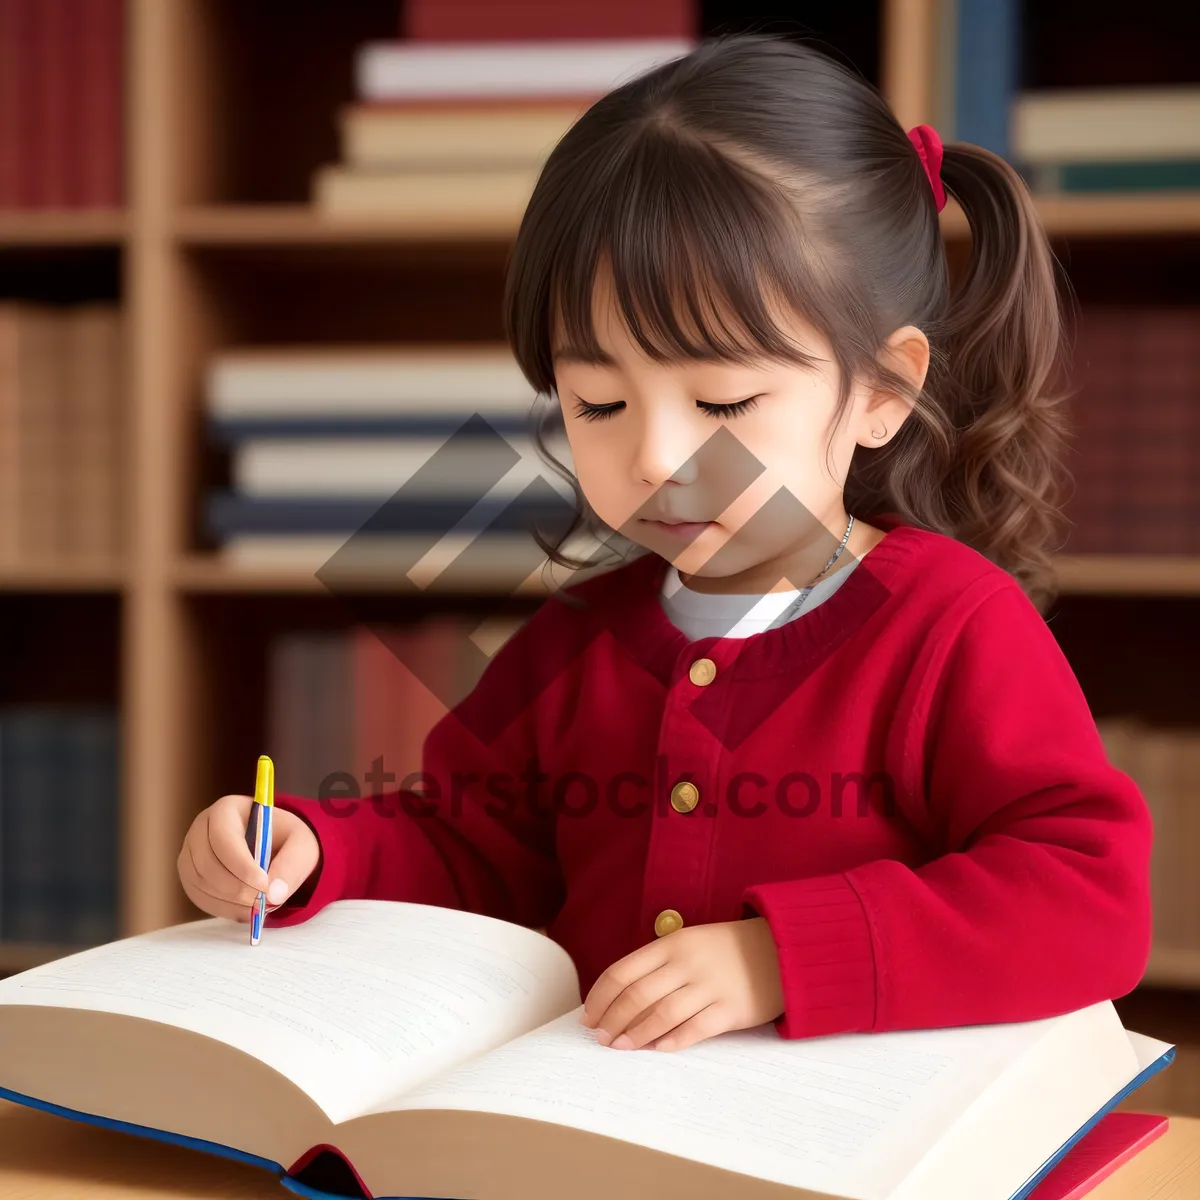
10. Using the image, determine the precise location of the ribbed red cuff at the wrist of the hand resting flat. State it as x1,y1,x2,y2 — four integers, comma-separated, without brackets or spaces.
742,875,876,1038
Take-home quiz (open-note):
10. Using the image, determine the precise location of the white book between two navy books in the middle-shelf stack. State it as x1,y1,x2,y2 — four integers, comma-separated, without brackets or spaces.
232,436,575,502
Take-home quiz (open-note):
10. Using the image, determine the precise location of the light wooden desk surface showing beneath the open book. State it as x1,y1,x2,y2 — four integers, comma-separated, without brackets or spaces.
0,1100,1200,1200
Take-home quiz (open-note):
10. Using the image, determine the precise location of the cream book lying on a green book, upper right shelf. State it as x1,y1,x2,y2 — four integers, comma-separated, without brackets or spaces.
1012,86,1200,163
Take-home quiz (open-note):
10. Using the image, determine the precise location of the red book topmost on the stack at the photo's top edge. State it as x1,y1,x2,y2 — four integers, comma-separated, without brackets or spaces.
401,0,700,42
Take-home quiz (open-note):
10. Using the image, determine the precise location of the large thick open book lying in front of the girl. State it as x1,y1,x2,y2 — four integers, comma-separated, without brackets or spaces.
0,900,1174,1200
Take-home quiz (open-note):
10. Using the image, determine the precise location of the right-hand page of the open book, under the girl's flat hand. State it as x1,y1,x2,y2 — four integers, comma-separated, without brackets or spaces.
372,1006,1113,1200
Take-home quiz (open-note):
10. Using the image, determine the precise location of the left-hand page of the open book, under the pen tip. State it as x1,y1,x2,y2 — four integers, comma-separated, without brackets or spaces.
0,900,580,1122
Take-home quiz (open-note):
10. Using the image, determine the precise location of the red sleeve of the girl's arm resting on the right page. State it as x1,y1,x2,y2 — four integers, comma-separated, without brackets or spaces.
743,583,1152,1038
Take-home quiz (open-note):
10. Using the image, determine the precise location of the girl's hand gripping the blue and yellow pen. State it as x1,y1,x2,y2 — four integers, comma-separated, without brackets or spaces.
175,796,320,922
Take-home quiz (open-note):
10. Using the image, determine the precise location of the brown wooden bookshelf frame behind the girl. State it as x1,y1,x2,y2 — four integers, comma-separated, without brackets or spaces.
0,0,1200,1099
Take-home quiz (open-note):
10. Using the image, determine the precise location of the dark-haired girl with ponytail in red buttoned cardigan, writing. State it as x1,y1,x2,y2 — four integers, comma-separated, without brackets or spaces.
179,36,1151,1050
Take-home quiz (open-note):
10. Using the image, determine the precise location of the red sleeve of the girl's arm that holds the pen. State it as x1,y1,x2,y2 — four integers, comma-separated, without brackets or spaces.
268,606,564,926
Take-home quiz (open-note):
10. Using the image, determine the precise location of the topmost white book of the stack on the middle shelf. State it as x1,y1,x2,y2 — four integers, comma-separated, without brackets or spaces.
206,343,535,418
